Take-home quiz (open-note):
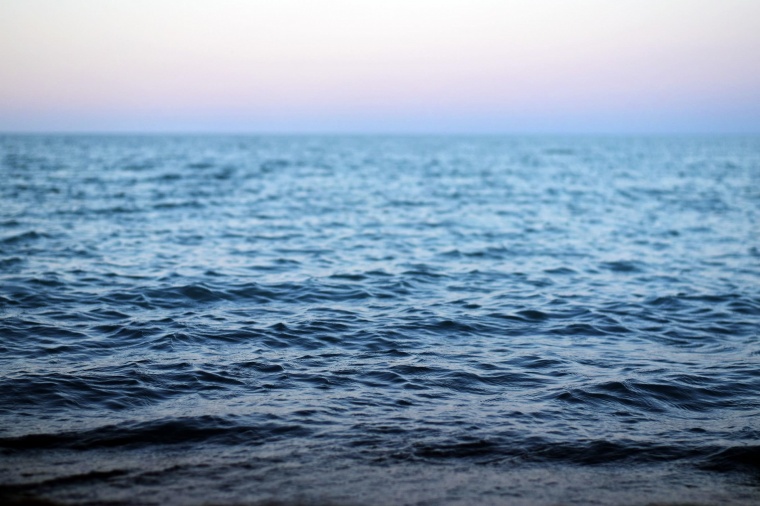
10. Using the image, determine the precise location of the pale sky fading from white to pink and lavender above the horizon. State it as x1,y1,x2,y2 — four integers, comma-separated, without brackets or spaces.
0,0,760,134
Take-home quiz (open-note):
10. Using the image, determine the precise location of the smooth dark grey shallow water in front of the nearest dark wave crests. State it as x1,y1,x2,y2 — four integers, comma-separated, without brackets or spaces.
0,444,760,506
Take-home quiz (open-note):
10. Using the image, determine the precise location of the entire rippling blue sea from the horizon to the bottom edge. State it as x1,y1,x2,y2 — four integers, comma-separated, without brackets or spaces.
0,136,760,505
